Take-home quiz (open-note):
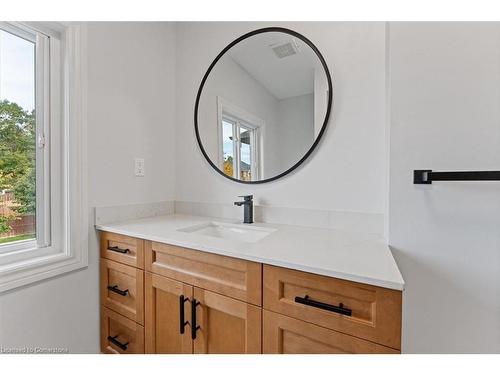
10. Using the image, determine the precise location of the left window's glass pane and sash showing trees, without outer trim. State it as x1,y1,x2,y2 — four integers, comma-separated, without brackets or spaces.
0,25,46,251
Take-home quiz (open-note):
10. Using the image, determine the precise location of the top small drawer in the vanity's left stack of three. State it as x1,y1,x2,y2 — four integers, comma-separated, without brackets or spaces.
101,232,144,269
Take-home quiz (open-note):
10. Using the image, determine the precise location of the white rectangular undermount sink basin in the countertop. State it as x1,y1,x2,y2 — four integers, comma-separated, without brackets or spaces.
179,221,276,243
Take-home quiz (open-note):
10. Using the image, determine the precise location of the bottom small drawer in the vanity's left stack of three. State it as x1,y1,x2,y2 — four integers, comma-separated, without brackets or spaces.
101,306,144,354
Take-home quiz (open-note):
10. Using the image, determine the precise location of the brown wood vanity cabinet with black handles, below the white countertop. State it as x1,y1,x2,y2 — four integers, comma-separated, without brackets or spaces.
101,232,402,354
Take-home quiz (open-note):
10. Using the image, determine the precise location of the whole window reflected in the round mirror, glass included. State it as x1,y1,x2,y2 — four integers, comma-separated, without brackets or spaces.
218,97,264,181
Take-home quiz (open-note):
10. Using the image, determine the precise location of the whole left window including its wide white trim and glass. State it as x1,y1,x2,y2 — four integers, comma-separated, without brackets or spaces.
0,22,88,292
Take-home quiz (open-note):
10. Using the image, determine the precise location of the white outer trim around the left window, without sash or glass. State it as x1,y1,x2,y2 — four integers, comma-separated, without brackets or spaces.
0,22,88,293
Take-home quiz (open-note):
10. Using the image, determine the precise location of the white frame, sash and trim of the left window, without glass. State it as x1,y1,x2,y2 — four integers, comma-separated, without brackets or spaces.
0,22,88,293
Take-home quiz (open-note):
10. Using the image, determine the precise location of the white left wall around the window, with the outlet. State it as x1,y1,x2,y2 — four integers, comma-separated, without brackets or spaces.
0,23,175,353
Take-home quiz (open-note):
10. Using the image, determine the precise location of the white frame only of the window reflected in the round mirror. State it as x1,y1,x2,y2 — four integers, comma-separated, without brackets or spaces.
217,96,265,180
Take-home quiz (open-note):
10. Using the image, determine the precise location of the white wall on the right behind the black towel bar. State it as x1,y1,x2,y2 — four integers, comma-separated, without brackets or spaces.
389,23,500,353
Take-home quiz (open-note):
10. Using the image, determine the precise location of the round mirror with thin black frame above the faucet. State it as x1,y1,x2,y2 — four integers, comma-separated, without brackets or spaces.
195,27,332,183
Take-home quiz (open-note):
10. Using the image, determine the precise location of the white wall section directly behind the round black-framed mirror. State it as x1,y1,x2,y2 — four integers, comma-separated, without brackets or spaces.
176,22,386,213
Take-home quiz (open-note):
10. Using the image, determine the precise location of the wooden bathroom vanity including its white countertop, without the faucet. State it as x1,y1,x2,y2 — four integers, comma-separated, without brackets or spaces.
97,215,404,354
